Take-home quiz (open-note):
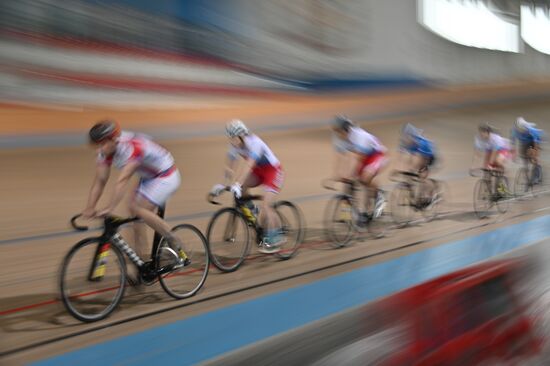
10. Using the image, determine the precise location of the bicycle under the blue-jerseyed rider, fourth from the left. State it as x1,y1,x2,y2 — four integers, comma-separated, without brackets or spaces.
390,170,443,226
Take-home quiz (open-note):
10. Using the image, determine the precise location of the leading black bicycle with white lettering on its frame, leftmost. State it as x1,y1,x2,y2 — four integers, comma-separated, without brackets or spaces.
59,208,209,322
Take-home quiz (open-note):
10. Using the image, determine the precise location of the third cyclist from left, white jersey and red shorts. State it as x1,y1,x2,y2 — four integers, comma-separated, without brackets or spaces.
332,115,388,217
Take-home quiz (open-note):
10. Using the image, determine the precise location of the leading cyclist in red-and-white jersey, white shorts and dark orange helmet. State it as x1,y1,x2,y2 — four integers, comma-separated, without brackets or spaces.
82,120,187,263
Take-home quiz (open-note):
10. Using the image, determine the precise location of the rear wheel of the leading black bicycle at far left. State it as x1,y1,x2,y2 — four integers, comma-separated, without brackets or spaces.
161,224,210,299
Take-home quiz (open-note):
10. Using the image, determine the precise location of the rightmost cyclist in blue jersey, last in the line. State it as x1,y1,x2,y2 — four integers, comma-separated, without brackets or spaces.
511,117,542,183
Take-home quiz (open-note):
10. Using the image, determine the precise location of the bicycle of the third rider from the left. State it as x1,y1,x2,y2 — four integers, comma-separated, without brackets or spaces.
322,179,390,248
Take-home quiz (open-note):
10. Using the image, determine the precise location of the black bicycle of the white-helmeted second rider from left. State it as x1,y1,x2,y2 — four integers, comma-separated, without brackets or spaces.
206,187,304,272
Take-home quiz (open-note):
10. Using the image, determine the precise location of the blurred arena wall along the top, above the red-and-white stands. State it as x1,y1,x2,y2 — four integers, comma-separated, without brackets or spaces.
0,0,550,93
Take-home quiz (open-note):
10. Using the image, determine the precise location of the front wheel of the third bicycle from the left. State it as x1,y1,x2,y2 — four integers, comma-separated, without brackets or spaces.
324,195,358,248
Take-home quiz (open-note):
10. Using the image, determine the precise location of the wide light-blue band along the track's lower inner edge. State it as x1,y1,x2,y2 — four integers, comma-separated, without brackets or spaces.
32,215,550,365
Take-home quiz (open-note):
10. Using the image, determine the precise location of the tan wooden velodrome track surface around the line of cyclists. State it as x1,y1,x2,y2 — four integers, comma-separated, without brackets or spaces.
0,87,550,364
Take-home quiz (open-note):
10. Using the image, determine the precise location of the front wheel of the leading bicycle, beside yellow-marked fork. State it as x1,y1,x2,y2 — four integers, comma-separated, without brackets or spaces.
59,238,126,322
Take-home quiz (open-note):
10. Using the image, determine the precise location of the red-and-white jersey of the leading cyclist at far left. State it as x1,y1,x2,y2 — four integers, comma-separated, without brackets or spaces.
97,131,174,179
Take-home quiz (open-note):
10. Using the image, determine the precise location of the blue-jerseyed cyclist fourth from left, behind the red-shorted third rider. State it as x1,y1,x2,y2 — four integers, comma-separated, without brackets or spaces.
399,123,436,206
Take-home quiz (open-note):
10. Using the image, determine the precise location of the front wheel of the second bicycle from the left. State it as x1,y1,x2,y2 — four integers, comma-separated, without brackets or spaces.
206,207,250,272
